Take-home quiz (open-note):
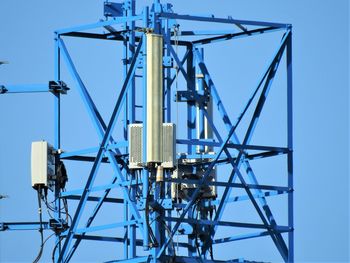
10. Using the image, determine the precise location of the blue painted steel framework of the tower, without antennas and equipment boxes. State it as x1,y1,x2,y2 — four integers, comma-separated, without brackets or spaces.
0,0,294,263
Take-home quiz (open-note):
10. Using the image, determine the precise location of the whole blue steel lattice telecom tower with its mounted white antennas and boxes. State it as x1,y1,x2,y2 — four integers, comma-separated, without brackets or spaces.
0,0,294,263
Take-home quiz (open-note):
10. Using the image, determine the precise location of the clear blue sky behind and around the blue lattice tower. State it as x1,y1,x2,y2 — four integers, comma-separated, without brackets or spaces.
0,0,350,262
